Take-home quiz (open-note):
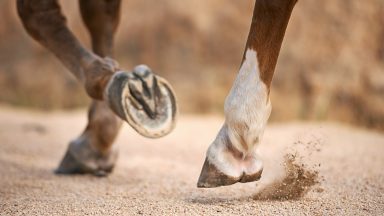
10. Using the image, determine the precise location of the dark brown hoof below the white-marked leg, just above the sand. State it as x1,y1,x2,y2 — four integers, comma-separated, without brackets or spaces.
197,159,263,188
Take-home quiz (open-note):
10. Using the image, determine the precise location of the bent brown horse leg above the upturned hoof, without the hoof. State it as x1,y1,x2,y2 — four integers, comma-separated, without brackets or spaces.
17,0,117,100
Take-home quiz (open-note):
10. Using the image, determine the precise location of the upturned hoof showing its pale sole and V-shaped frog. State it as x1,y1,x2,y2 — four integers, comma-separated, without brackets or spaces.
105,65,177,138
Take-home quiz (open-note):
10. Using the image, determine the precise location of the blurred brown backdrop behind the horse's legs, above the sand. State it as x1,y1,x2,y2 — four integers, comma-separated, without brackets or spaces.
0,0,384,131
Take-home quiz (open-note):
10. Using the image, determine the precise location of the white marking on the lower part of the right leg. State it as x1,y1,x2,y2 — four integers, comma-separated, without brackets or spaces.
207,49,271,177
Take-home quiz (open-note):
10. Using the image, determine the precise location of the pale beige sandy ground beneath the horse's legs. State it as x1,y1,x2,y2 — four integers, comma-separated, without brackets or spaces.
0,107,384,215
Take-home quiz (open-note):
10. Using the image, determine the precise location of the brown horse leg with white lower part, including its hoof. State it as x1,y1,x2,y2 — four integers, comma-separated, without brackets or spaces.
197,0,296,187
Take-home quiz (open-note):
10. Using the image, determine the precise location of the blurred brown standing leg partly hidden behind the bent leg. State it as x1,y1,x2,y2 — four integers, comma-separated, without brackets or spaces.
57,0,122,175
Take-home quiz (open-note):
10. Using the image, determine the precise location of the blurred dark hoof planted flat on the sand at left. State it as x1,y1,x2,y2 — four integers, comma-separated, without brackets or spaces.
55,141,117,176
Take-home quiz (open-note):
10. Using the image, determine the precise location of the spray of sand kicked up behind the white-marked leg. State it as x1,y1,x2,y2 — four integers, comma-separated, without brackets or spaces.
253,134,324,200
